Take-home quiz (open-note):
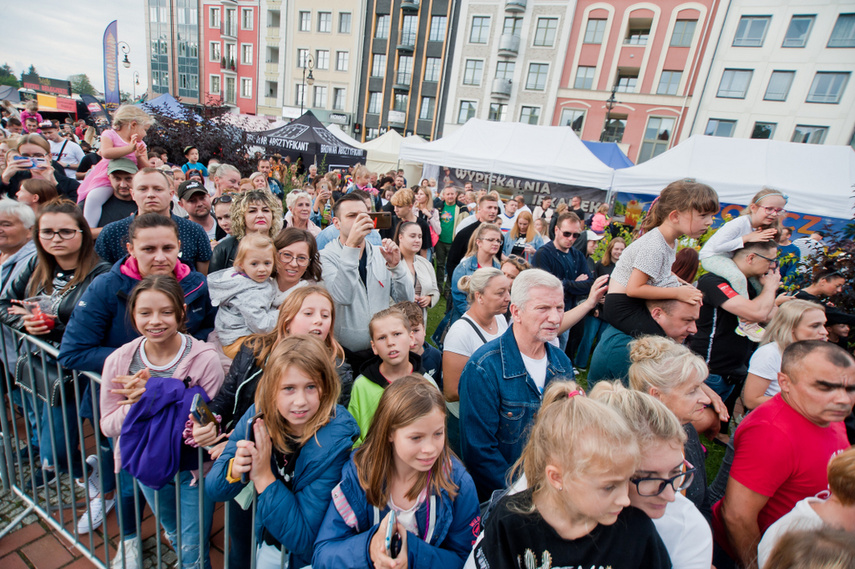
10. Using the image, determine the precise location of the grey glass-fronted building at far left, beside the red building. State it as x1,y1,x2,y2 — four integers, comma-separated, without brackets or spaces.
145,0,204,103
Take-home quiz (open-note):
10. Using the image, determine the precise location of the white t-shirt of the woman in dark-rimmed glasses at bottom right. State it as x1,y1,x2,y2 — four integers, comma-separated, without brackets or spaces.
653,493,712,569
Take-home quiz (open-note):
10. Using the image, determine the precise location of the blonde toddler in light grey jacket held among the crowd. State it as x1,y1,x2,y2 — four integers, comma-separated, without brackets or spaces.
208,233,279,359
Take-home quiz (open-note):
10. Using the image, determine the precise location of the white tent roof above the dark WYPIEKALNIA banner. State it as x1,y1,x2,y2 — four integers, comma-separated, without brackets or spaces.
400,119,613,190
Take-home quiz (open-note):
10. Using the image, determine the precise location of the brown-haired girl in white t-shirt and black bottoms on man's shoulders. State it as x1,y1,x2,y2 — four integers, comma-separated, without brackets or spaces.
603,180,719,336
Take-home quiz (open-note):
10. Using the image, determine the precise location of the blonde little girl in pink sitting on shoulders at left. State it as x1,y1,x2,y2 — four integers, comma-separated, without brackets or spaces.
77,105,154,227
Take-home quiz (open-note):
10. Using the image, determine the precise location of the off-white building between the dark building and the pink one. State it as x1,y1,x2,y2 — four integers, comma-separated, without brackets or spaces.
444,0,576,134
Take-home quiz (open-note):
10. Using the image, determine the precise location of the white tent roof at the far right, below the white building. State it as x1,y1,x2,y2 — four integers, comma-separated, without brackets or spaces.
612,135,855,219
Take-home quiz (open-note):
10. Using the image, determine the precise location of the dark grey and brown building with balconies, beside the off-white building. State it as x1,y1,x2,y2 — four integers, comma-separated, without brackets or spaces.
357,0,457,140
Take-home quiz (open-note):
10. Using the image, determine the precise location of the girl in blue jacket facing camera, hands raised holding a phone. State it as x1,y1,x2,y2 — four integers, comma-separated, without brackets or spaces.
205,335,359,569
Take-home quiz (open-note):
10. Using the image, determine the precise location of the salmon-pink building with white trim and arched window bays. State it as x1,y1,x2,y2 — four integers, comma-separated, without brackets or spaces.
550,0,720,163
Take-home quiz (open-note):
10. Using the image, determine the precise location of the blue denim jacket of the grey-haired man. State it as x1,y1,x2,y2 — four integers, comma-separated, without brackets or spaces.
459,326,573,498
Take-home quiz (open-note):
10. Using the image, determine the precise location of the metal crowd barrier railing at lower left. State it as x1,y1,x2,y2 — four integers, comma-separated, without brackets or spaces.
0,325,278,569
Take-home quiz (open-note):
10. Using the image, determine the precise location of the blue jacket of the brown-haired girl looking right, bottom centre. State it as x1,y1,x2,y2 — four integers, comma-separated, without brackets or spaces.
312,457,481,569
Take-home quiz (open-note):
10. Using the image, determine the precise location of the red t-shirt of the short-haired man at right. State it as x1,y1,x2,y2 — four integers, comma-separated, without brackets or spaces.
713,393,849,549
